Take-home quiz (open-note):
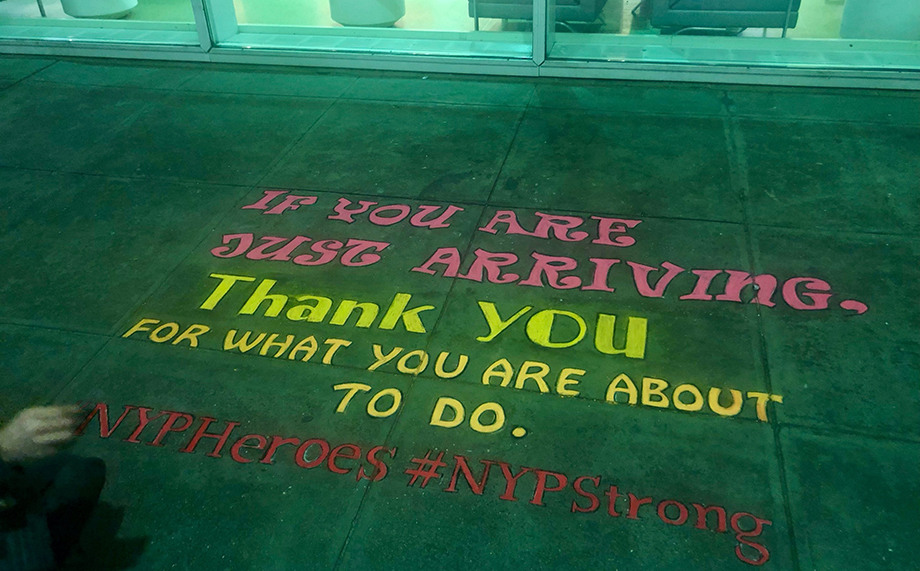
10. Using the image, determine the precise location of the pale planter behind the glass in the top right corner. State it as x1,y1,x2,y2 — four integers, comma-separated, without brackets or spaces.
840,0,920,41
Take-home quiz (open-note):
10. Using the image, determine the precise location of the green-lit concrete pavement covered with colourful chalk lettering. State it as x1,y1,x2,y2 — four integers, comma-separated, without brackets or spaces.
0,56,920,571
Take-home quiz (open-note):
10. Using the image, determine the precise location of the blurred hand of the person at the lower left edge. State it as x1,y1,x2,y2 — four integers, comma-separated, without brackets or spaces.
0,406,79,462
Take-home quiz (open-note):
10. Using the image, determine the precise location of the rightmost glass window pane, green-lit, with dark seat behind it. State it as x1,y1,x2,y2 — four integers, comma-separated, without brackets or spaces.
548,0,920,68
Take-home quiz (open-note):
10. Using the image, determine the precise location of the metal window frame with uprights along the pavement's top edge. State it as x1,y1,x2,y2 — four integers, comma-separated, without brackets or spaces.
0,0,920,90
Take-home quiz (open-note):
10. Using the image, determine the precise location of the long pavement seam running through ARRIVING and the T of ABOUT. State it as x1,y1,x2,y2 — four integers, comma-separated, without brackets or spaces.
723,113,801,571
